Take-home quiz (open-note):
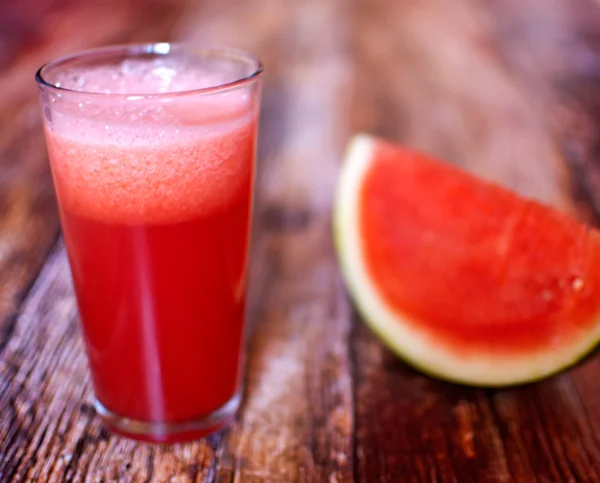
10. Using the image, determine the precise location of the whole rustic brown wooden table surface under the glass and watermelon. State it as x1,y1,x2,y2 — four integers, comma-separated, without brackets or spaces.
0,0,600,483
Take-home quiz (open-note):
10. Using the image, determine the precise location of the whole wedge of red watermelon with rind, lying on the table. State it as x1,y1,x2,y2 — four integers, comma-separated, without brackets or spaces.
334,135,600,386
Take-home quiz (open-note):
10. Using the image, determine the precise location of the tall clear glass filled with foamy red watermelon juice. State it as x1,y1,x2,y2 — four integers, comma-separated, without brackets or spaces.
36,43,262,442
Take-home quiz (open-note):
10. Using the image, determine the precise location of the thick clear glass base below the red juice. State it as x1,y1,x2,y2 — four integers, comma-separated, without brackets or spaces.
94,394,241,443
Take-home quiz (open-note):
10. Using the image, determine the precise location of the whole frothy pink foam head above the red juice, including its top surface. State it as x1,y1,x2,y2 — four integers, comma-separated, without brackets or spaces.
46,58,258,223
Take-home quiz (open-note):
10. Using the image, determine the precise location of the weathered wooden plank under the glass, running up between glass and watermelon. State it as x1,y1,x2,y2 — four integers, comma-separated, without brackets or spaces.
0,0,353,482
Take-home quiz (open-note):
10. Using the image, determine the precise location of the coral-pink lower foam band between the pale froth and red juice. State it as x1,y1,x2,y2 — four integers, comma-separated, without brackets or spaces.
48,122,255,223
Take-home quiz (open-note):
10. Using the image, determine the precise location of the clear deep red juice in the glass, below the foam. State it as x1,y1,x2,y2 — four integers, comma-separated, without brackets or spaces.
62,195,249,422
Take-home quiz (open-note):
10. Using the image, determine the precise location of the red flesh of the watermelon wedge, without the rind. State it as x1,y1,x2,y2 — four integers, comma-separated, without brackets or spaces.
358,142,600,354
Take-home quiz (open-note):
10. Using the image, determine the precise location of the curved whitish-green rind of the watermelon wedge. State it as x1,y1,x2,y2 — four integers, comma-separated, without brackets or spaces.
333,134,600,387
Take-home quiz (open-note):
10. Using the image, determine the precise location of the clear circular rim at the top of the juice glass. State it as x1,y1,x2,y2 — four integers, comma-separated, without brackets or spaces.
35,42,264,100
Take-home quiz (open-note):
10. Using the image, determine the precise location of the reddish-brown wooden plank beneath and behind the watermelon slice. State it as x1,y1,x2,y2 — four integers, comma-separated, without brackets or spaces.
353,0,600,482
